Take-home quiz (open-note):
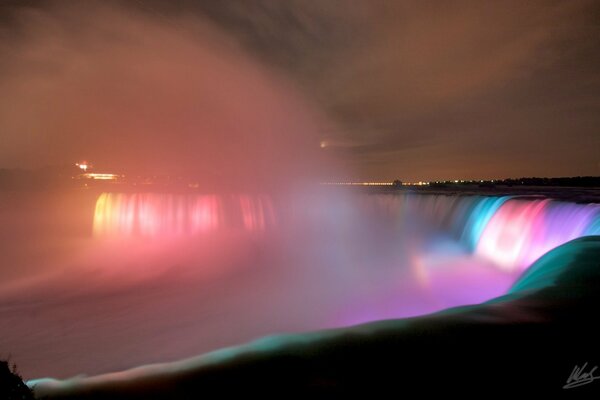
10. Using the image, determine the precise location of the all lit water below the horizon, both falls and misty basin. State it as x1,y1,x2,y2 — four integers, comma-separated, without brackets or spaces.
0,193,600,378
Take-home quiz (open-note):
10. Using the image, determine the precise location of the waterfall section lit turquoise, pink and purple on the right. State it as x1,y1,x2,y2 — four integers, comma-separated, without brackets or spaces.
364,194,600,272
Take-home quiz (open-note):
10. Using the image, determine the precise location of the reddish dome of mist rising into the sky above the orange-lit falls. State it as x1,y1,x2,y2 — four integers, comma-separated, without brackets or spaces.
0,2,340,188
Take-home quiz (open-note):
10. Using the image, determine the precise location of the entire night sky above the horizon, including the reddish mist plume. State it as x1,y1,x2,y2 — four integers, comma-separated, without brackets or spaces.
0,0,600,180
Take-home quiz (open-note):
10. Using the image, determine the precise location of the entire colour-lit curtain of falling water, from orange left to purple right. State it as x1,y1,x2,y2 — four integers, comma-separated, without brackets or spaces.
94,193,600,272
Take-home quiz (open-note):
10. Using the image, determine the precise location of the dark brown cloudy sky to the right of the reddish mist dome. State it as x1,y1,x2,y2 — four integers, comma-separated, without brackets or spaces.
164,1,600,179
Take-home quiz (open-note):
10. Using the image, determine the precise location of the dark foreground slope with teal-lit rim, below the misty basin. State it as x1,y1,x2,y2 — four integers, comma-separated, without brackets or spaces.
30,236,600,399
